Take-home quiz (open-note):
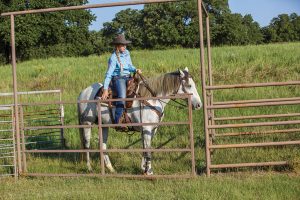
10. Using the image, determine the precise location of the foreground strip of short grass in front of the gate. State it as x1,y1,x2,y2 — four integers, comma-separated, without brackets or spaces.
0,173,300,200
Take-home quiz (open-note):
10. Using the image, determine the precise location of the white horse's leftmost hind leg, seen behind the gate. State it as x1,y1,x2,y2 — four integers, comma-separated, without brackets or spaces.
80,122,92,171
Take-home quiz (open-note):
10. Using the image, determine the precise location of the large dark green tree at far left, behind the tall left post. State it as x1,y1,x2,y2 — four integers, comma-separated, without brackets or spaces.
0,0,95,62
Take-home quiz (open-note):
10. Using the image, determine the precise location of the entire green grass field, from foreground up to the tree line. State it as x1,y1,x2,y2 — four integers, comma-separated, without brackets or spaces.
0,43,300,199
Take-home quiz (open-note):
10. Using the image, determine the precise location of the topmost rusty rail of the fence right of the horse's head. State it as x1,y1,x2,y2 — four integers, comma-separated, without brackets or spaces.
205,81,300,90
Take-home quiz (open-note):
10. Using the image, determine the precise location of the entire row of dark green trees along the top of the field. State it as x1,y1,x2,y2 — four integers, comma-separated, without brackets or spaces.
0,0,300,64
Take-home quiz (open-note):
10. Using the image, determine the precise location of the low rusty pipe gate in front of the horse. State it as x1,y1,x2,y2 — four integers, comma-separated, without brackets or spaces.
18,94,196,178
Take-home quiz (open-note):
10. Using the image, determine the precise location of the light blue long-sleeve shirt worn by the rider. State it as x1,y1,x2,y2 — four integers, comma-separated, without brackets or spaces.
104,50,136,89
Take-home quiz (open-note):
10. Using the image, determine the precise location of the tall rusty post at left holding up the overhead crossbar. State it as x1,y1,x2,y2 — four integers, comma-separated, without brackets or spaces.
10,15,22,173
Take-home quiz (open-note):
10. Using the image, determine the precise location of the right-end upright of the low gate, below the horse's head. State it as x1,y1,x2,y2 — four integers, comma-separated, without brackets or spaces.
188,95,196,176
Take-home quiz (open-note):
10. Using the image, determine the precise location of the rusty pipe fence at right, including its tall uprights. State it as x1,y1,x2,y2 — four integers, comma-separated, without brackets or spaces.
198,0,300,176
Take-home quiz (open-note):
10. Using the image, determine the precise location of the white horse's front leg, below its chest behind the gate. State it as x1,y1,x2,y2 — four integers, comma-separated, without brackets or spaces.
141,127,154,175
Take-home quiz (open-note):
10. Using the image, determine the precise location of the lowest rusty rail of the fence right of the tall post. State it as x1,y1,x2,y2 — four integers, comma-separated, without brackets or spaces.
210,161,288,169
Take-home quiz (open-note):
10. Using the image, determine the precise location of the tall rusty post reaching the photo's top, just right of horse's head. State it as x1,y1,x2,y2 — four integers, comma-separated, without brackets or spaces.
198,0,211,176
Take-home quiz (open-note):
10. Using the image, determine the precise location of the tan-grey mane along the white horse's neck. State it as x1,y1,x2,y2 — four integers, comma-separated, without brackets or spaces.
139,71,180,97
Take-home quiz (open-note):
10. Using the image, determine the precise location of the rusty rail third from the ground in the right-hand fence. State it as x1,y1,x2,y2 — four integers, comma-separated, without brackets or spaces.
207,120,300,129
